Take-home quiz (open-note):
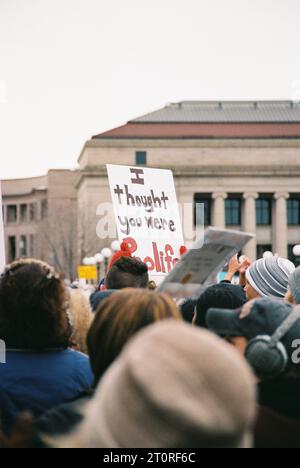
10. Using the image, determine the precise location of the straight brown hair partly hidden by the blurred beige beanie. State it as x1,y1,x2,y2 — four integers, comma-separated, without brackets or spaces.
87,289,181,383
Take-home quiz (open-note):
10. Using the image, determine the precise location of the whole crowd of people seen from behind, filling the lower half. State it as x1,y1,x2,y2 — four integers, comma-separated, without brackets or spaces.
0,243,300,448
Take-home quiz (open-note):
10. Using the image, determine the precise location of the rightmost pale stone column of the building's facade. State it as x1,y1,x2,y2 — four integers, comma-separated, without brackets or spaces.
273,192,290,258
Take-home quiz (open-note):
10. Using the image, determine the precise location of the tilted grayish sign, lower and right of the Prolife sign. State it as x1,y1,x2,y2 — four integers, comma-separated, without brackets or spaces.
159,228,254,297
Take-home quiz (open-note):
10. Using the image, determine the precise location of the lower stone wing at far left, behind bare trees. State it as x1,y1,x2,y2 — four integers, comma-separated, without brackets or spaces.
1,170,78,277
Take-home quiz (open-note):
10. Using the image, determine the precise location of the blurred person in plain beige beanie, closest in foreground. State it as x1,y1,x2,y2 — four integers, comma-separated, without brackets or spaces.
48,319,256,448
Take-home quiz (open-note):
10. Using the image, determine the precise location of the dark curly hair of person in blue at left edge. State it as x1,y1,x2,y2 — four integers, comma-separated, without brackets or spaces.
0,259,72,351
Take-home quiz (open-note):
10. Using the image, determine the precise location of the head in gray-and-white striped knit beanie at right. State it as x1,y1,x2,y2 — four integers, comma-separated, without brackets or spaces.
245,255,295,299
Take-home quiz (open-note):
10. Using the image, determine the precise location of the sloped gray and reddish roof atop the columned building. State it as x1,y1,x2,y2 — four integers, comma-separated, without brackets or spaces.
93,101,300,139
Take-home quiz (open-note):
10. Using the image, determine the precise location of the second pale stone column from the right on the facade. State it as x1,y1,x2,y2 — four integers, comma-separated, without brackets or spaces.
243,192,258,261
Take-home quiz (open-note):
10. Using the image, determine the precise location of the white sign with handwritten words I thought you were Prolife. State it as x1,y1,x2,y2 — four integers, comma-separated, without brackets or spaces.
107,164,183,276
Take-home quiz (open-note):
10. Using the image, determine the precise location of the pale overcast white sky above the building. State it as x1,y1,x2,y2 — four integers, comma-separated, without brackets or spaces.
0,0,300,178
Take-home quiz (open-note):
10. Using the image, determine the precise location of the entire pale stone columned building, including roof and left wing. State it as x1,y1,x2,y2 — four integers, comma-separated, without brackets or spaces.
3,101,300,274
